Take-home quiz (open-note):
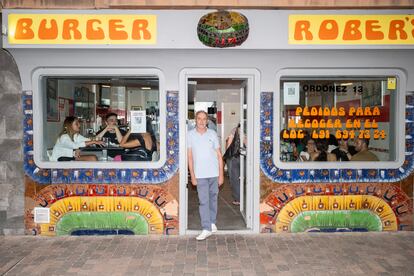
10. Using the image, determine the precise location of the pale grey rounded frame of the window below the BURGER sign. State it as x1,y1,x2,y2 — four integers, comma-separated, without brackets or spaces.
32,67,167,169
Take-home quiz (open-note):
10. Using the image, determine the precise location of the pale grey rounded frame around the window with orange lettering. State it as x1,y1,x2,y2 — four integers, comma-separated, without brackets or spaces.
273,68,407,169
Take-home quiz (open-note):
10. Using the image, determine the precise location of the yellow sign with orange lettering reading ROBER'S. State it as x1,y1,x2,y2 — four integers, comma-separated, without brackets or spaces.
289,14,414,45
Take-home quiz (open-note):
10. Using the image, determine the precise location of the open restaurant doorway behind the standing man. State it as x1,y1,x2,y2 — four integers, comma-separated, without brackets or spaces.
187,77,252,231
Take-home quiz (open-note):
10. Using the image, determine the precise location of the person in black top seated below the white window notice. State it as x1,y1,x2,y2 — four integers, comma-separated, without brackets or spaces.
120,119,157,161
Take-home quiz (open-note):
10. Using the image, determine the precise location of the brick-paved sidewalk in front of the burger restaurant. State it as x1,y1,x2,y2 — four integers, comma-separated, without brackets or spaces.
0,232,414,276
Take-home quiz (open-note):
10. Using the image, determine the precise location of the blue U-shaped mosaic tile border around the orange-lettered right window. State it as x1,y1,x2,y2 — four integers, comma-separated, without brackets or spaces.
260,92,414,183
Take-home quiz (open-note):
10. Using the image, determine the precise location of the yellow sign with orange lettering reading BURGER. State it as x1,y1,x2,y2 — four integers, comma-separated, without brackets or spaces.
8,14,157,45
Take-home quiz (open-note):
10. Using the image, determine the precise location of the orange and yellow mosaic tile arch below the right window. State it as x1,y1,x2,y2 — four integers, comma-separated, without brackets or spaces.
260,183,413,233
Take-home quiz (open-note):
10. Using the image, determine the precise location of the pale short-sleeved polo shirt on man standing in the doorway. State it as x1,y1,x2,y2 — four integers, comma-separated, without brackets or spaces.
187,129,220,178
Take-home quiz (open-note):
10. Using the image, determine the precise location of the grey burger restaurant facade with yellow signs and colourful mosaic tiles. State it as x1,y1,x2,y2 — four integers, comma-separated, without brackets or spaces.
0,5,414,236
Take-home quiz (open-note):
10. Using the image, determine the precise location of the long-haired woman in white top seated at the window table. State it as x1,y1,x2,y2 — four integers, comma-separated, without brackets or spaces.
51,116,103,161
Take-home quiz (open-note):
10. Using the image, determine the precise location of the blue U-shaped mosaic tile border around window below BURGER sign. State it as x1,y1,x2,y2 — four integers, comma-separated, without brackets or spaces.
23,91,179,184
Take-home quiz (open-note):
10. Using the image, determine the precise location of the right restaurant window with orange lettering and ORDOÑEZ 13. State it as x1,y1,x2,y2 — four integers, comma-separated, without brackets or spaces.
274,68,404,169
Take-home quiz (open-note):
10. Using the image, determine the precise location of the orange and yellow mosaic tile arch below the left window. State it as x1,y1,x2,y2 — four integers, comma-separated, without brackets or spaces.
25,183,178,236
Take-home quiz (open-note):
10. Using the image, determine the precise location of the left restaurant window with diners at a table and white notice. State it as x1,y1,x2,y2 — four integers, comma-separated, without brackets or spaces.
34,68,165,168
